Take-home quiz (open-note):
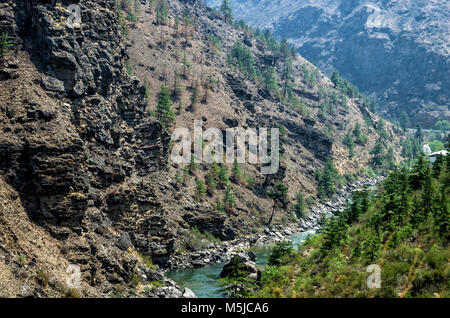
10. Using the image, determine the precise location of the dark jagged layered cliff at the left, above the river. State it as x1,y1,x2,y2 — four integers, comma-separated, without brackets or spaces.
0,0,171,296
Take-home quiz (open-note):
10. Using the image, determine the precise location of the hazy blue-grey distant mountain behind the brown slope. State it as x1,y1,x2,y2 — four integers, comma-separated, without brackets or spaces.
208,0,450,128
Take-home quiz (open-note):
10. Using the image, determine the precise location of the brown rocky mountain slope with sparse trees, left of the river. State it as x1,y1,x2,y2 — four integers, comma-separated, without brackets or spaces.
0,0,398,297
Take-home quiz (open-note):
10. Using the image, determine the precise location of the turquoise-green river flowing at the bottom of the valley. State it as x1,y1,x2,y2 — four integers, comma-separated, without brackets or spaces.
166,230,315,298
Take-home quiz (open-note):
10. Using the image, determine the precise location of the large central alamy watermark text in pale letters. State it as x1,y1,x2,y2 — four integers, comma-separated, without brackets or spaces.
170,120,280,175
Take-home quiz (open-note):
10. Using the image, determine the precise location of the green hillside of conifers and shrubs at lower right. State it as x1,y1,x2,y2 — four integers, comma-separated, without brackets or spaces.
251,156,450,298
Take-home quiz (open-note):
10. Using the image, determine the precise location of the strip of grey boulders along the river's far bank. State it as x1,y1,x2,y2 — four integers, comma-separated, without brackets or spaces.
166,176,383,272
